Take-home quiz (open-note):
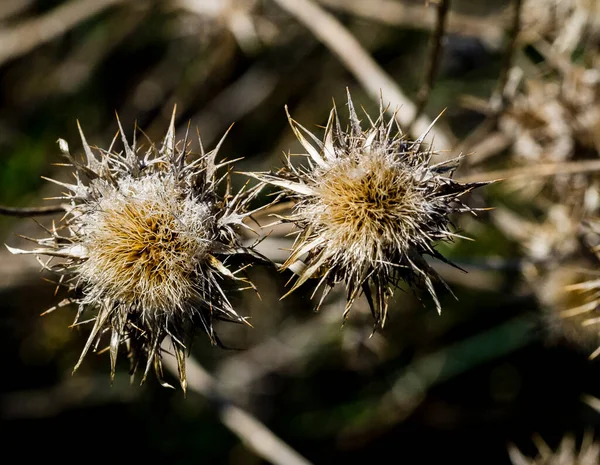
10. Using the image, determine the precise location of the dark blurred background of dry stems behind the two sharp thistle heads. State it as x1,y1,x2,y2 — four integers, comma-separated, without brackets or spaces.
0,0,600,464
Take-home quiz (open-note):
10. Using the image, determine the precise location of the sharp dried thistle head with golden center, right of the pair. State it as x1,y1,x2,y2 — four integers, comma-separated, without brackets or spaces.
251,93,483,326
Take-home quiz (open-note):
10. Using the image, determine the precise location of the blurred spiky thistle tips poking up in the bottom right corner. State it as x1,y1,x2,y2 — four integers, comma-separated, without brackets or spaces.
508,432,600,465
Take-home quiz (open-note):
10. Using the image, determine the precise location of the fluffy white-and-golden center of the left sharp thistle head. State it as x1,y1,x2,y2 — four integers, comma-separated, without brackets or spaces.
80,178,209,312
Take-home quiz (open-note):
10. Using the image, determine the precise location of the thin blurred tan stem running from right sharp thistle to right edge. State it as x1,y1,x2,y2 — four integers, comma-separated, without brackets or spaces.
457,160,600,182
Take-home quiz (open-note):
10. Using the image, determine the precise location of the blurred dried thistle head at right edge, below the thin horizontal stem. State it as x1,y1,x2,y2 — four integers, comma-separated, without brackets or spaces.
502,212,600,358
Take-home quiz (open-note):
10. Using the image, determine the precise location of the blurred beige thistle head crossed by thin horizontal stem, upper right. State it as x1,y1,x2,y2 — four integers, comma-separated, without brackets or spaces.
499,59,600,203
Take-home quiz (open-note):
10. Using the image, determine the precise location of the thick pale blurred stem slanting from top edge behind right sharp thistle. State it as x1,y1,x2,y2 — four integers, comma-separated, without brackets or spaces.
274,0,454,147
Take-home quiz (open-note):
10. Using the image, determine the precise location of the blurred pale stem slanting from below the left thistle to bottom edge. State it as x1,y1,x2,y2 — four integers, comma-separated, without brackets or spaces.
163,342,310,465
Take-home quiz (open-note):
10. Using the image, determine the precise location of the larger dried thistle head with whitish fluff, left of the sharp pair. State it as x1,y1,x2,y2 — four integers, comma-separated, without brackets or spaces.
10,109,260,390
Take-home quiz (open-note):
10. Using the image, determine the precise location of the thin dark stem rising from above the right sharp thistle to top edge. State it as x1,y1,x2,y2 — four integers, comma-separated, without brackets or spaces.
407,0,450,133
